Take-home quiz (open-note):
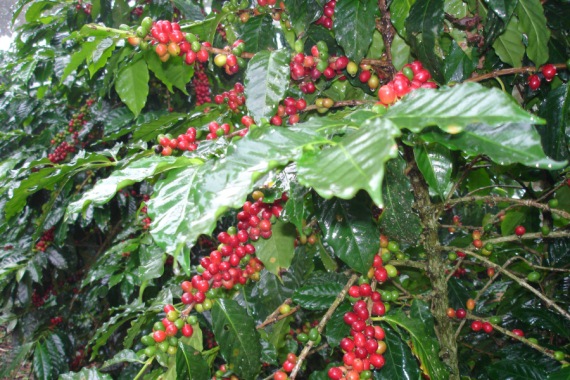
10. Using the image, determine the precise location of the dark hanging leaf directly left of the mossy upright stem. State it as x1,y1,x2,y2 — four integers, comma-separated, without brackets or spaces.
380,158,422,244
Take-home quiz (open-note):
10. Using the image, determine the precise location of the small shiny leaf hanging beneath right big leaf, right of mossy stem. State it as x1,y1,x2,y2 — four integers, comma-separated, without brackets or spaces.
414,144,453,199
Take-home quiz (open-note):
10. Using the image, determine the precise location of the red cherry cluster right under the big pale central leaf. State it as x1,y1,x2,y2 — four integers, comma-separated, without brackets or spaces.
237,190,288,241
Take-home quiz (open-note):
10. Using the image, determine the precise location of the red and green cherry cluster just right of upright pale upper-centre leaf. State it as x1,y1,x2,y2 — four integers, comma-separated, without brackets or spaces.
289,40,349,94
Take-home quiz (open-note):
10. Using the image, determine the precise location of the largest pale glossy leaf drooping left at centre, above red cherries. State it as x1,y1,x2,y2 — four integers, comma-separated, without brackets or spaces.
148,127,319,260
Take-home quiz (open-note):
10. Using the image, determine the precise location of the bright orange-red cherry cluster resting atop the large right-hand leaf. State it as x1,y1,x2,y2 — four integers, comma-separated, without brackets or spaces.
378,61,437,106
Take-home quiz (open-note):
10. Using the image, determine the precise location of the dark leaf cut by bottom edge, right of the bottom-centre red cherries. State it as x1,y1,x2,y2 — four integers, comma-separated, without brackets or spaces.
374,326,421,380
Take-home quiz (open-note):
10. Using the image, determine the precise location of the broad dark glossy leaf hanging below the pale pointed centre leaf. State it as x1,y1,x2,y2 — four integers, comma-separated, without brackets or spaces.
316,196,380,273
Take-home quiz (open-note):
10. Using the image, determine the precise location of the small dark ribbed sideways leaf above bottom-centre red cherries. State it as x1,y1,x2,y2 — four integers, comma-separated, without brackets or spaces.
293,272,347,310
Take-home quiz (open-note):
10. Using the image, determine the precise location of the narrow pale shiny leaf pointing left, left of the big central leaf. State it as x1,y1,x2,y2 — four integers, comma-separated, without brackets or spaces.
67,156,195,214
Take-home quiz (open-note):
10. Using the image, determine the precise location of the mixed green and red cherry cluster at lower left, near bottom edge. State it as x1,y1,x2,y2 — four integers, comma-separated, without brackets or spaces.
141,305,198,357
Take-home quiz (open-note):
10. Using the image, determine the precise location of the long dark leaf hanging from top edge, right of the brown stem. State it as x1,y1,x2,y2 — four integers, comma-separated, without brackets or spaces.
405,0,444,82
